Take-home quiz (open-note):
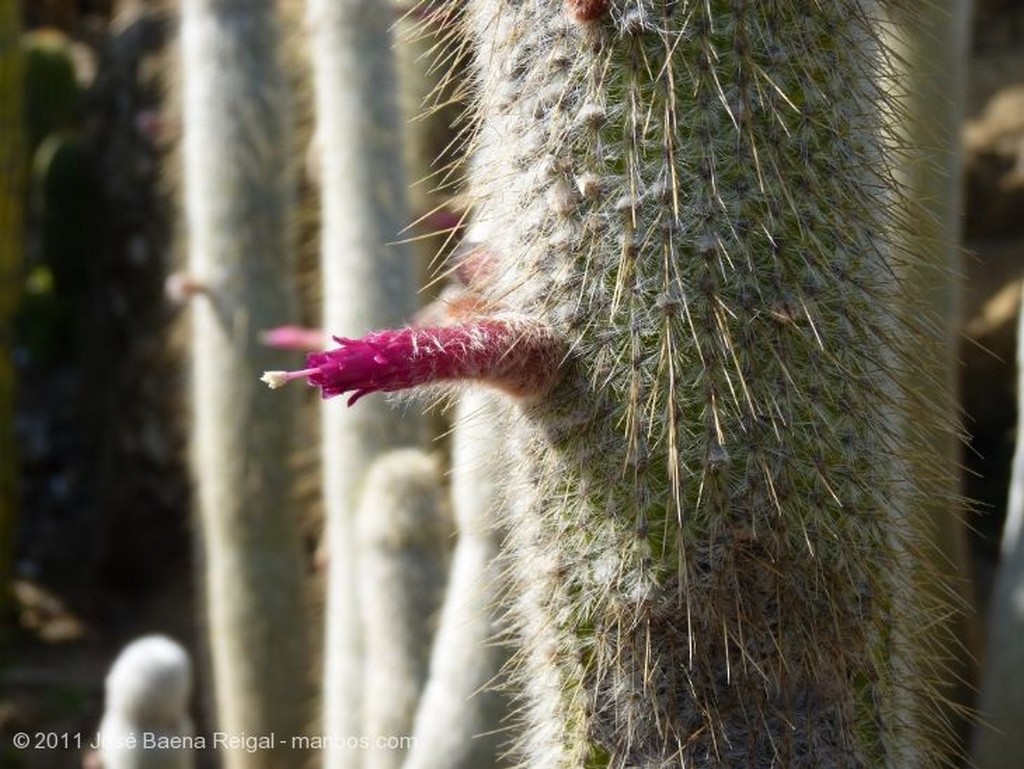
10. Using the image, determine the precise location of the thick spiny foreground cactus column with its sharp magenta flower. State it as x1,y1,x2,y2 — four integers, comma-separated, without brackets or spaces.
271,0,946,769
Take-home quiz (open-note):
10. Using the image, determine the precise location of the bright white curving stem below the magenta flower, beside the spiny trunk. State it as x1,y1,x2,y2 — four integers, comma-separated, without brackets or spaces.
402,390,508,769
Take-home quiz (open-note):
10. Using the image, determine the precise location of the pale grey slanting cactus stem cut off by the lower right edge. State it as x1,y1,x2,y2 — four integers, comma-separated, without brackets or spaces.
972,284,1024,769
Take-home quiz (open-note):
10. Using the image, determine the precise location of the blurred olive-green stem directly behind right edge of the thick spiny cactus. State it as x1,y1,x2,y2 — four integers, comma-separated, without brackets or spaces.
888,0,980,760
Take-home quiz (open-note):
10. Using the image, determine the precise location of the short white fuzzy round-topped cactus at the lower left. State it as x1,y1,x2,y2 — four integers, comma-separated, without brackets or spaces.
97,636,196,769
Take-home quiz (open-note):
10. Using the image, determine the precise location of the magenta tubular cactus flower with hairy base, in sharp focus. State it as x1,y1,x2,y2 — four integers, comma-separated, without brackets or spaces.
256,318,563,405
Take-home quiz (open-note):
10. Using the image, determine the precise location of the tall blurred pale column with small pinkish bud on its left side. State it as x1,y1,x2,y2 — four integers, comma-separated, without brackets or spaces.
181,0,310,769
